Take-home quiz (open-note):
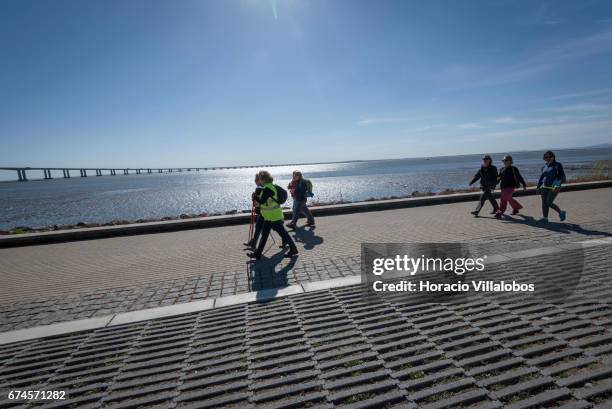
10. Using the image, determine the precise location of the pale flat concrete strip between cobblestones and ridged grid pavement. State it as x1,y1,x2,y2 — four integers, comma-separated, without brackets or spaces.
0,237,612,345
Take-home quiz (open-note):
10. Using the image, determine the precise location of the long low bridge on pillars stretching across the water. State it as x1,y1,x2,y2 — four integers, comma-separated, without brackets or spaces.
0,164,291,182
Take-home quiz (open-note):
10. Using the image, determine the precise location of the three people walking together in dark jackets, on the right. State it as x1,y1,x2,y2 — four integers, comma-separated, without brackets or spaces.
470,151,567,223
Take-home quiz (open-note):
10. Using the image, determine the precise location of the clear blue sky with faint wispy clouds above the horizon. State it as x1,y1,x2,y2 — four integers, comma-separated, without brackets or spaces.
0,0,612,167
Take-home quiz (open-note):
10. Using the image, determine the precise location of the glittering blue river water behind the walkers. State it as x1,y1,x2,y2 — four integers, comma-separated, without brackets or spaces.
0,148,612,229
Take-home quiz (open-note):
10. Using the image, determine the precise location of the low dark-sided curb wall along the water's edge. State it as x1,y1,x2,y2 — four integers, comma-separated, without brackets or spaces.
0,180,612,248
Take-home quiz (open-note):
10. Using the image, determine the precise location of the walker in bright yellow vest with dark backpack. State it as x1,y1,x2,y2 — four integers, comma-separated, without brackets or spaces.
247,170,298,259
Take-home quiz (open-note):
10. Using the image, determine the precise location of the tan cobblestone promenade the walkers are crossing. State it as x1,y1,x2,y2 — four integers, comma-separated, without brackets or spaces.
0,189,612,330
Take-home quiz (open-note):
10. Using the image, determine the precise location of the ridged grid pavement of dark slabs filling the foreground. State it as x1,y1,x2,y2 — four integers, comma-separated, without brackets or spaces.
0,247,612,409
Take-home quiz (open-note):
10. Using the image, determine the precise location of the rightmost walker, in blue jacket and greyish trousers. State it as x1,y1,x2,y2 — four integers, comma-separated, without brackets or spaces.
536,151,567,223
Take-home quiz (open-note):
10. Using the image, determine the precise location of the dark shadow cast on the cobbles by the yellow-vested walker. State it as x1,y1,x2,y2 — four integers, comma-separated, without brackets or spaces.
247,251,297,299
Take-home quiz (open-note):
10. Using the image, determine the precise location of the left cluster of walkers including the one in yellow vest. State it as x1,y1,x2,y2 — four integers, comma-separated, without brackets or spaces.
245,170,315,259
